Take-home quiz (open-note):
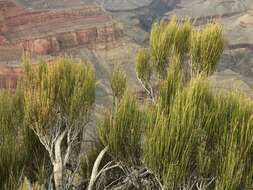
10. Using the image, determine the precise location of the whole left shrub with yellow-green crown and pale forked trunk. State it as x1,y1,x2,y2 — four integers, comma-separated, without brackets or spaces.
22,58,95,190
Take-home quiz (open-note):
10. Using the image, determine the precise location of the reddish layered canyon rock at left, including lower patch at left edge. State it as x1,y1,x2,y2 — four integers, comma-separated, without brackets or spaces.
0,0,123,88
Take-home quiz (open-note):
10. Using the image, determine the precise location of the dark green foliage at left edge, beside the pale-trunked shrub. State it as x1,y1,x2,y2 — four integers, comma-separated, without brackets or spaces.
0,88,48,190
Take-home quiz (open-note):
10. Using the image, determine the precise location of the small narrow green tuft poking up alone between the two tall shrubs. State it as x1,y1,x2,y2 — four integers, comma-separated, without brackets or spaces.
110,67,127,100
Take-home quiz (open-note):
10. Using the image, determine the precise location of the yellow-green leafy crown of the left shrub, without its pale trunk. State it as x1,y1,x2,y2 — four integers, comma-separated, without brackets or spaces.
23,58,95,135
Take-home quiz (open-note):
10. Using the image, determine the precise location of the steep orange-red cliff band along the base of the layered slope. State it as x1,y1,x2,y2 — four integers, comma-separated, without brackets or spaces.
16,23,122,54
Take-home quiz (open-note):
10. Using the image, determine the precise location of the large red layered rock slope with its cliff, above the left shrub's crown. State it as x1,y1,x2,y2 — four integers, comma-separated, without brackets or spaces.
0,0,122,58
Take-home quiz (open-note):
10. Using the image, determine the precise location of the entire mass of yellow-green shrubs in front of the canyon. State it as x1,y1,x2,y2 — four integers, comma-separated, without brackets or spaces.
0,18,253,190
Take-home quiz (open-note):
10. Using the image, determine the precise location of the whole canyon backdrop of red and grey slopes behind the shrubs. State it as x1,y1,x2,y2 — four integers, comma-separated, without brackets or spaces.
0,0,253,102
